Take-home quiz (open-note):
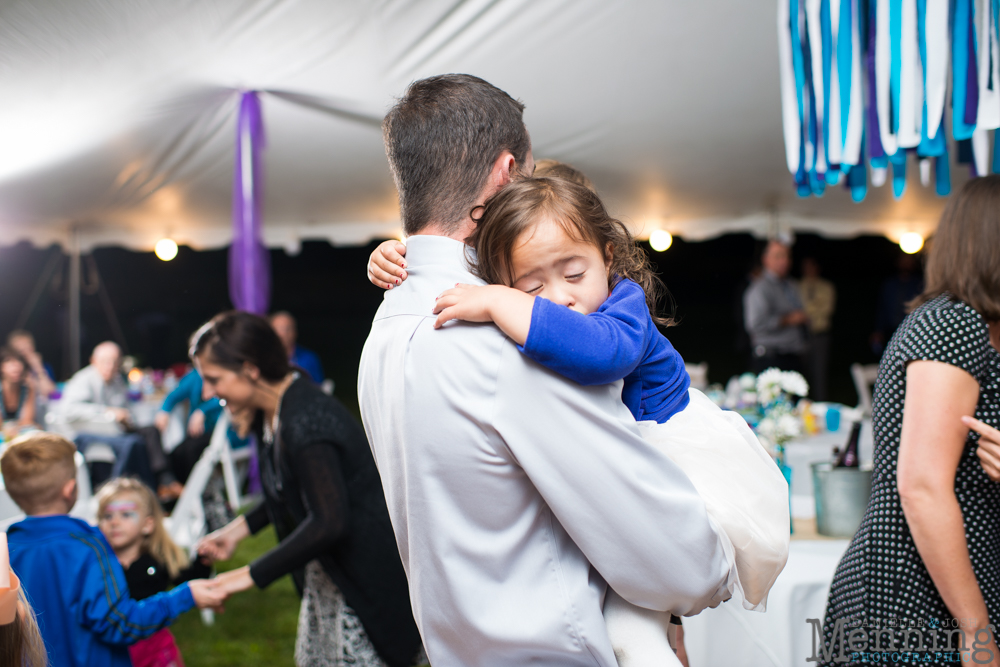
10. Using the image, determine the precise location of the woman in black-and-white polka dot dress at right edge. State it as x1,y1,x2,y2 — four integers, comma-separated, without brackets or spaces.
818,176,1000,666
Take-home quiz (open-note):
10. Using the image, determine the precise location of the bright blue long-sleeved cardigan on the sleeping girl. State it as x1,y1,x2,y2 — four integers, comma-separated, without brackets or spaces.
519,279,691,424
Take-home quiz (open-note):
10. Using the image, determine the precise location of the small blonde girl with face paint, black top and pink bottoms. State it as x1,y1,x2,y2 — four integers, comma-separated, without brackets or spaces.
97,477,211,667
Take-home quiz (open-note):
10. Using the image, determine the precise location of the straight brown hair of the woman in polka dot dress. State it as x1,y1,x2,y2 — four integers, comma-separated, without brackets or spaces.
910,174,1000,322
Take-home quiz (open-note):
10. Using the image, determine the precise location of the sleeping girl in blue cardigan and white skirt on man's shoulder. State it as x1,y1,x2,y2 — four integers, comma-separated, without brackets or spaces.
373,178,789,665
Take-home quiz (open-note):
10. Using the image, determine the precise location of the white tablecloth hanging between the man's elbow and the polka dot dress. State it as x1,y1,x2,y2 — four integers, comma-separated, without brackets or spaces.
684,540,848,667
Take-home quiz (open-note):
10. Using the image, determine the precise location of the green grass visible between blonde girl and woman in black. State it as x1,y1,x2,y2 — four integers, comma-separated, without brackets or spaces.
171,527,300,667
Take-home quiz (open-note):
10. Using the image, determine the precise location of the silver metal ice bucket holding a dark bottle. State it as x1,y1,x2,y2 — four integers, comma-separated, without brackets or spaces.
810,462,872,537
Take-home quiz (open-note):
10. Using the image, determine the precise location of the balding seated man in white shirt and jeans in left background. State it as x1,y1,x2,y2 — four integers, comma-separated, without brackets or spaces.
59,341,182,499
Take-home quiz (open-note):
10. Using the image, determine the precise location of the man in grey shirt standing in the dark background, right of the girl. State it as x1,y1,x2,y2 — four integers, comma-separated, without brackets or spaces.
743,239,808,373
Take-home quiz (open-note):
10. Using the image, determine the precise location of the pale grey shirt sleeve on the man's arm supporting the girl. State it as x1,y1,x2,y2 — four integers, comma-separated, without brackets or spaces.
493,343,731,615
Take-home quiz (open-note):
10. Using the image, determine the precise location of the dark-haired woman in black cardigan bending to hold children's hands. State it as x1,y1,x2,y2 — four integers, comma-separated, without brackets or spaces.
191,312,420,667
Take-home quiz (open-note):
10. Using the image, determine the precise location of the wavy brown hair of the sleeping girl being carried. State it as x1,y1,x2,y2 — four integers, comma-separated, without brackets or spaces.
467,177,676,327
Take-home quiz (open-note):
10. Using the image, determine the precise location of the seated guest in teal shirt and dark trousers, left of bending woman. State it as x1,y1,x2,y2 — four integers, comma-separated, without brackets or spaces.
156,370,222,484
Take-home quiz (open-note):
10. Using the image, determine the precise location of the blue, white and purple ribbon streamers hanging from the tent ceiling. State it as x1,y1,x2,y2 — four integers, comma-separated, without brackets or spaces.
778,0,1000,201
